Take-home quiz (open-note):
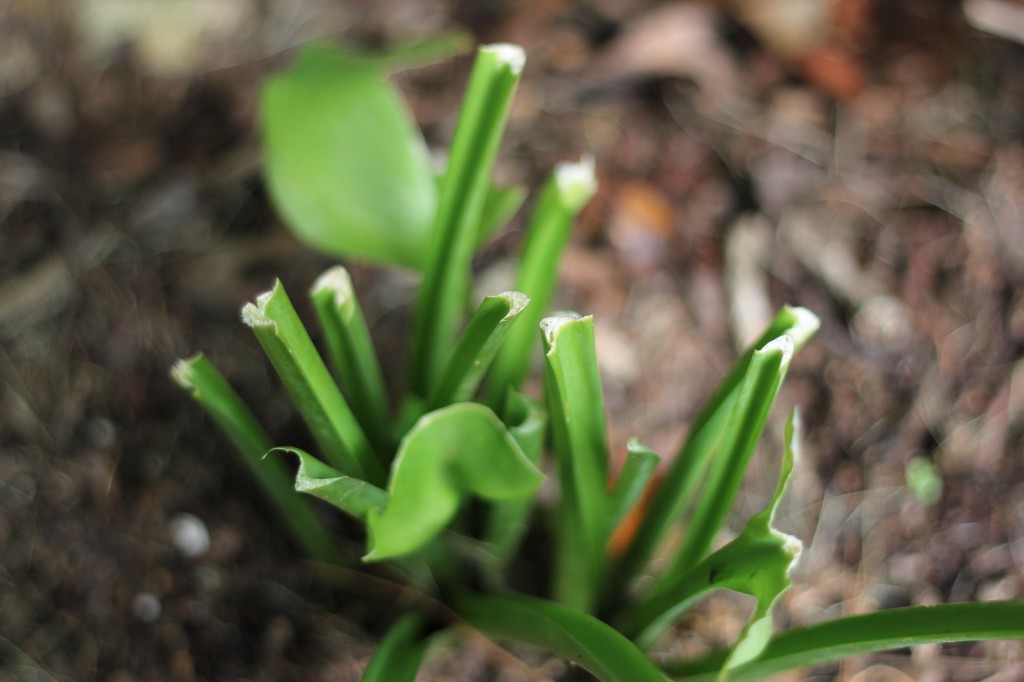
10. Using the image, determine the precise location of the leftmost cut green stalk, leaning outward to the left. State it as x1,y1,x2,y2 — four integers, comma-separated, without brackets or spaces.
171,354,338,562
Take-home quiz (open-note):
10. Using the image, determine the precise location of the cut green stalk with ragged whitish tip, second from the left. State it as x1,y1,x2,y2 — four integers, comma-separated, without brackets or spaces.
242,280,384,483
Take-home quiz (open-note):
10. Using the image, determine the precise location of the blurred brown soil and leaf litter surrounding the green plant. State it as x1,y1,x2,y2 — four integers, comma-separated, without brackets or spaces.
0,0,1024,682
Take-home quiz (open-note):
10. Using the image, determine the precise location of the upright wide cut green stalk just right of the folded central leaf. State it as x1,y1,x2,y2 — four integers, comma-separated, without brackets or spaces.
541,313,611,611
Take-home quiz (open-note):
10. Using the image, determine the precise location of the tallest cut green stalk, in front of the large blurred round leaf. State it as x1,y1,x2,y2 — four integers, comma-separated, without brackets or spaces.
411,44,525,397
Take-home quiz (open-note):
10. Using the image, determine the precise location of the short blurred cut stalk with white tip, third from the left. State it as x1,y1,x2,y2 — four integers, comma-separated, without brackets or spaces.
309,265,394,459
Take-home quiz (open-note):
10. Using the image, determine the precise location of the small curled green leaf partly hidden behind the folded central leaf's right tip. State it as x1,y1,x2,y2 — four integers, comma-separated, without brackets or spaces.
483,391,548,587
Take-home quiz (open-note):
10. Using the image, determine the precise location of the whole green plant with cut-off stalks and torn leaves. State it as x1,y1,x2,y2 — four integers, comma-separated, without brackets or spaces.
173,45,1024,682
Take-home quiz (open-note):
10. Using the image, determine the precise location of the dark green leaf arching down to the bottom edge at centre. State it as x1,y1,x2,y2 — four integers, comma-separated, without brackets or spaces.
455,593,668,682
